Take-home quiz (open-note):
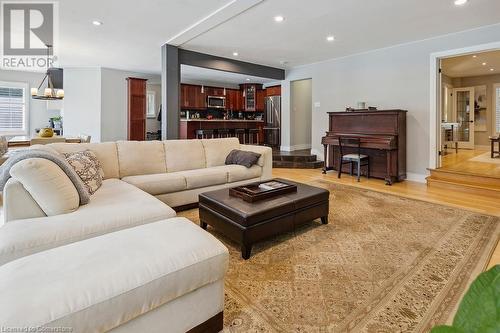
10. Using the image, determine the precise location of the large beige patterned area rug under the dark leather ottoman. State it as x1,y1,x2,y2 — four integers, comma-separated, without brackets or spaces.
179,181,500,332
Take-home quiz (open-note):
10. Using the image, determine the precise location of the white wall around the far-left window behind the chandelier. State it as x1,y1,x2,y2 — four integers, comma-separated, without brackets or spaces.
0,70,62,135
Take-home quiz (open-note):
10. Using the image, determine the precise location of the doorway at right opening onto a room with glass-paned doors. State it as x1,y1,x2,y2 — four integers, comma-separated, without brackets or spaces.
437,50,500,178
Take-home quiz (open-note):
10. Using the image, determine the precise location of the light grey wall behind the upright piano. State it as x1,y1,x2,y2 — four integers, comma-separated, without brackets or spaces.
282,24,500,180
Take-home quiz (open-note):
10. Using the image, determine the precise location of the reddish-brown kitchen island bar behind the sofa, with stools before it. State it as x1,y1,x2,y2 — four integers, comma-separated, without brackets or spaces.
179,119,264,144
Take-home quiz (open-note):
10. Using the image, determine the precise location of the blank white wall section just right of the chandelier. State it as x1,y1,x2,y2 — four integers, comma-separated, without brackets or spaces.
63,68,101,142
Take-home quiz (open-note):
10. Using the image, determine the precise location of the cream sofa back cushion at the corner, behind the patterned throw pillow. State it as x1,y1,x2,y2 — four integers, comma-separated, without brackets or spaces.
47,142,120,179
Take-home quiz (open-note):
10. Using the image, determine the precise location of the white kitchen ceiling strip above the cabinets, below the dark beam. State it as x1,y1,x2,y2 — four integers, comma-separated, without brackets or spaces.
181,65,275,88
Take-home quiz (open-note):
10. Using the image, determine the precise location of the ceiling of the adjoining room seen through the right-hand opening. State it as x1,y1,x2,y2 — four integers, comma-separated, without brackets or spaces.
441,51,500,77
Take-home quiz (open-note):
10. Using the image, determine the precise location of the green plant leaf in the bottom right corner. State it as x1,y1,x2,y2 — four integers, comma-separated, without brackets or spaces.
431,265,500,333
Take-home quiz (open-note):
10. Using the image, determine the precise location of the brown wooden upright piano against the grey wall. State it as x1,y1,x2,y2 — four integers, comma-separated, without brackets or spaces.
321,110,407,185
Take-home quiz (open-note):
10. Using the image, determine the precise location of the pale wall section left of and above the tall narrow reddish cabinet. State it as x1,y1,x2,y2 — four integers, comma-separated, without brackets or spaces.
101,68,161,141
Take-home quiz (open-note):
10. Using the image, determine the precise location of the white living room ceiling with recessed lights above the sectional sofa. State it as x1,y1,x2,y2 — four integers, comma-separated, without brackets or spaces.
59,0,500,73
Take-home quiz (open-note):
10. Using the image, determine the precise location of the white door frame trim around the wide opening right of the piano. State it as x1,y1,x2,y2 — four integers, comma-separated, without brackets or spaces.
429,42,500,169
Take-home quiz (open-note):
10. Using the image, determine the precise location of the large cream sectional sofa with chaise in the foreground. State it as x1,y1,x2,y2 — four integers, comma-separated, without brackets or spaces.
0,138,272,332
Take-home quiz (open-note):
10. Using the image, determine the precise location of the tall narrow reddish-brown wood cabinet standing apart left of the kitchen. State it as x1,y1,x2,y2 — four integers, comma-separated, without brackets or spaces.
127,77,147,141
